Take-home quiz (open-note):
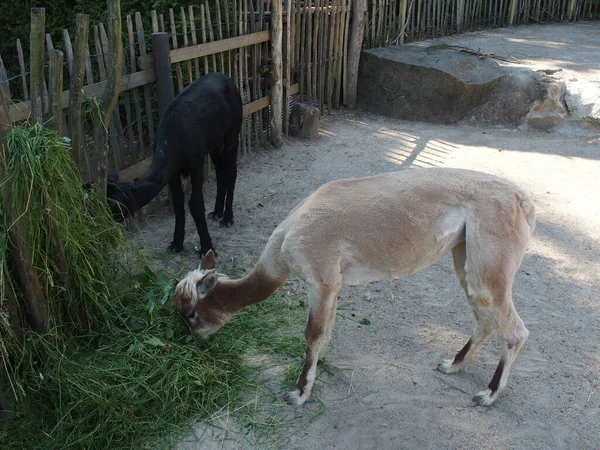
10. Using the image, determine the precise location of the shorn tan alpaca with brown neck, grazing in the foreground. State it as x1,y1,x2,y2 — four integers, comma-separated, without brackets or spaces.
174,169,535,405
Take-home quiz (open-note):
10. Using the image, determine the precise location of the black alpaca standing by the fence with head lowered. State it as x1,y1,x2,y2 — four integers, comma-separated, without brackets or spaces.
107,72,243,256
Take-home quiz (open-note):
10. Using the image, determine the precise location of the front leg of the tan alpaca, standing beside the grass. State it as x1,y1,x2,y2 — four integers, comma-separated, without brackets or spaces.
284,285,340,405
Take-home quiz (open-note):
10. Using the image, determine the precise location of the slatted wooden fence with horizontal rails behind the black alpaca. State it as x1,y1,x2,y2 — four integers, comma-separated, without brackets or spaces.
0,0,351,179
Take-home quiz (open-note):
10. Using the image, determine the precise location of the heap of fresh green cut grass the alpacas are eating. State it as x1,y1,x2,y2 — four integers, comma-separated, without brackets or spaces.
0,122,304,449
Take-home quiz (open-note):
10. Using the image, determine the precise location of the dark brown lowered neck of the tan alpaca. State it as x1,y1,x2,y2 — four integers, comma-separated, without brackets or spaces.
215,264,287,314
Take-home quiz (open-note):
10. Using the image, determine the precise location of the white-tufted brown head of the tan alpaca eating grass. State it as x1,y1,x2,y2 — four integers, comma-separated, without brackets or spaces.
173,250,231,339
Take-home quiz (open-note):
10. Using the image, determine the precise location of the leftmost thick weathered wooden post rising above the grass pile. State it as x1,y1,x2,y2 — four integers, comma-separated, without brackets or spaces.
29,8,46,123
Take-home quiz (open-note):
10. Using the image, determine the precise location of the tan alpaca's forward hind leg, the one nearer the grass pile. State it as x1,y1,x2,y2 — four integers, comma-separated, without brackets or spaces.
437,242,492,374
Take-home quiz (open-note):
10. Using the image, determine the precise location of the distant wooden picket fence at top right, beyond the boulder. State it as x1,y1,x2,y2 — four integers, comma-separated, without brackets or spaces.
364,0,600,48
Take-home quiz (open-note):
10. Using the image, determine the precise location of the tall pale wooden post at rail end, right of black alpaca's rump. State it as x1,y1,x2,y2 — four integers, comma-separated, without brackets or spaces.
271,1,283,147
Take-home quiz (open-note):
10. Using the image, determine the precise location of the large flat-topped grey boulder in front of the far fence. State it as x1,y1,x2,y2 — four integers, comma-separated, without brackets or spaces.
358,43,505,123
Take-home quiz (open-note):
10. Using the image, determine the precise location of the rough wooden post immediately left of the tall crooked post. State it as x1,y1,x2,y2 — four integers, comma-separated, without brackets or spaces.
69,14,90,170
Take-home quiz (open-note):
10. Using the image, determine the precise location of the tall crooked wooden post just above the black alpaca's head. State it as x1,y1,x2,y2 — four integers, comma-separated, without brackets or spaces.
93,0,123,194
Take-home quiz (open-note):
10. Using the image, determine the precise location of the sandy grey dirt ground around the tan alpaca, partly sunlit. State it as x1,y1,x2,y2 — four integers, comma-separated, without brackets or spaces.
135,23,600,450
